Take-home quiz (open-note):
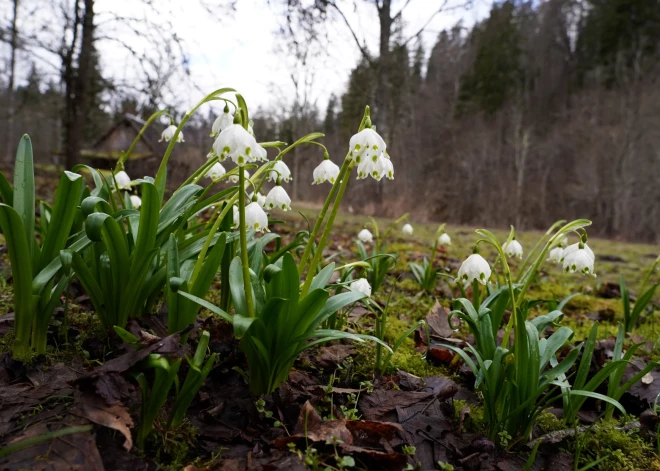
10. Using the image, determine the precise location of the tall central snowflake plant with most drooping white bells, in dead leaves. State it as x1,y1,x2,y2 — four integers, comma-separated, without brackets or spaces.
175,102,391,394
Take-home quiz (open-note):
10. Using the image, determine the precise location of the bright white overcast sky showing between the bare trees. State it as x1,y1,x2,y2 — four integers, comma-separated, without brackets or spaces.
2,0,489,113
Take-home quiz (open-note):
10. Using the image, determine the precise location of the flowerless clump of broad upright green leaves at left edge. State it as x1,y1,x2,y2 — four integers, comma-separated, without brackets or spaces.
0,135,85,359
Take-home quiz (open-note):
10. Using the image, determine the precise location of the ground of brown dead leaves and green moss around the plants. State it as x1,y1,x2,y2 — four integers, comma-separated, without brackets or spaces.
0,171,660,471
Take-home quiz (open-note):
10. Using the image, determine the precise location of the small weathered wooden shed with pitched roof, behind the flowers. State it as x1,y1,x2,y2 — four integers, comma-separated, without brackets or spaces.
81,114,167,178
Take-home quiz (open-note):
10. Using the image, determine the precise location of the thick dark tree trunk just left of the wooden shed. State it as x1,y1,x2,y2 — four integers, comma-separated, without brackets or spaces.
64,0,94,168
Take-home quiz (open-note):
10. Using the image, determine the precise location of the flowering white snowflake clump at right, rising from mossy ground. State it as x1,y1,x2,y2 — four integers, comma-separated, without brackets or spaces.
446,219,636,447
